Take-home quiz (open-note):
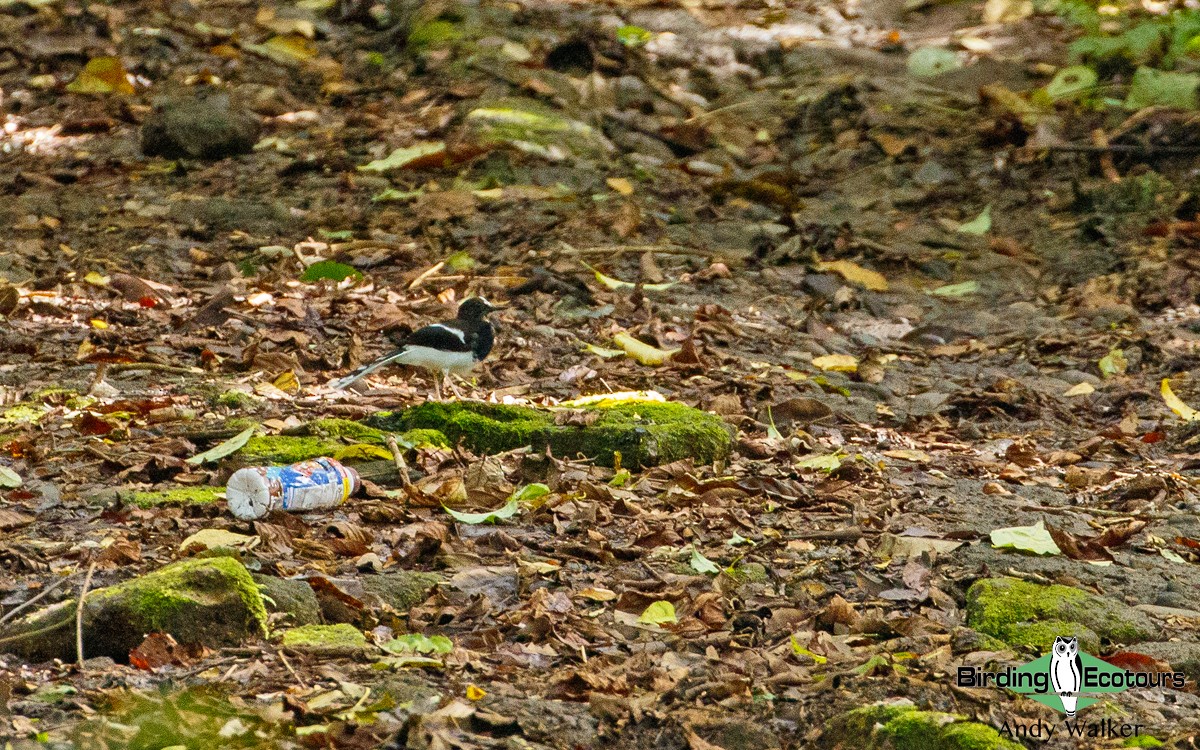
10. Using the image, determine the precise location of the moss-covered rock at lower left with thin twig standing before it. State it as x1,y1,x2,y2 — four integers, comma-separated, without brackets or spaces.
0,557,266,661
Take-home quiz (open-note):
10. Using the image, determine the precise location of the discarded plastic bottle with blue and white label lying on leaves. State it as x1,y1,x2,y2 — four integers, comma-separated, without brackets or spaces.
226,458,359,521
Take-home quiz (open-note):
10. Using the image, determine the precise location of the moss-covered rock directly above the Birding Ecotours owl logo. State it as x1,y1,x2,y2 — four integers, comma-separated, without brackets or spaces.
967,578,1158,652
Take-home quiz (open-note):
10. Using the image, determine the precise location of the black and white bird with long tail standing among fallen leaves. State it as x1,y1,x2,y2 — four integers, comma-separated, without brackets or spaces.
331,296,496,400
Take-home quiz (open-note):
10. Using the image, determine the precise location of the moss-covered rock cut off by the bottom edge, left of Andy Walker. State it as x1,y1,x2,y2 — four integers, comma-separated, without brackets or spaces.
817,701,1022,750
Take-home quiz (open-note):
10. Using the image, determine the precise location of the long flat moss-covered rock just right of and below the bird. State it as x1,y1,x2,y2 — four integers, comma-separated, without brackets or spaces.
367,401,731,467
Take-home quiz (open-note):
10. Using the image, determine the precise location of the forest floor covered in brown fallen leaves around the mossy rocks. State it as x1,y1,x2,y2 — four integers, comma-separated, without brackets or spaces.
0,0,1200,750
